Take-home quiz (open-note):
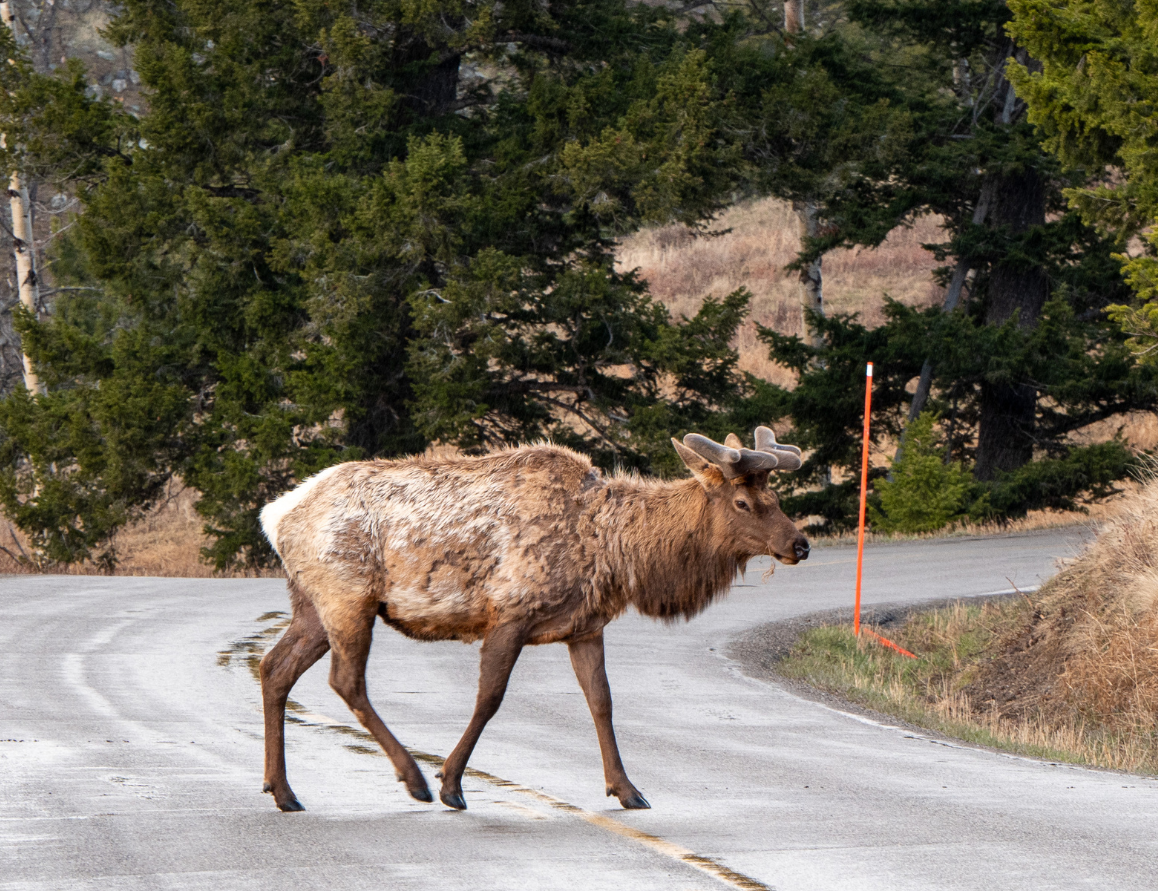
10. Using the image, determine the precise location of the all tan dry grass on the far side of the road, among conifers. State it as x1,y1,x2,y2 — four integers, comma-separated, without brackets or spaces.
0,199,1134,577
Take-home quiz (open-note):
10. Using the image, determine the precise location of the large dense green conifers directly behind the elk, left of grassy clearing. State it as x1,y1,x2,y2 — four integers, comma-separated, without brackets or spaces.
0,0,747,567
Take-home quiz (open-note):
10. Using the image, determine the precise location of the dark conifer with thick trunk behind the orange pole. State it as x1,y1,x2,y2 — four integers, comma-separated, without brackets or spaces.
745,0,1158,525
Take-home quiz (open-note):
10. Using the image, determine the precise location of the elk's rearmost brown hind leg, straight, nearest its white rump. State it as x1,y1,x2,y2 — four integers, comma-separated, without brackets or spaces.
259,585,330,811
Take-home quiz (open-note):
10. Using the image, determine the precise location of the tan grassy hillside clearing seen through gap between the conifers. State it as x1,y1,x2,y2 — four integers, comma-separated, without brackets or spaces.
617,198,943,384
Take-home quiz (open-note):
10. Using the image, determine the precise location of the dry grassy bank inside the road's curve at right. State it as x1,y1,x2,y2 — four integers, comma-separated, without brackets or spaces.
784,479,1158,773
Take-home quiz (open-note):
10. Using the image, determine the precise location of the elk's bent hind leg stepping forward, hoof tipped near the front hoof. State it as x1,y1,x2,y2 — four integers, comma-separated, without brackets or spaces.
330,605,434,802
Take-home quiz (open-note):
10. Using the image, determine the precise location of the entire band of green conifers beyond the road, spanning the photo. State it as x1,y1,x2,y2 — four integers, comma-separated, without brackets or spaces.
0,0,1158,568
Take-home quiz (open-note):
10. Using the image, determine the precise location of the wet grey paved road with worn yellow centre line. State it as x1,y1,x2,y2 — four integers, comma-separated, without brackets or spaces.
0,530,1158,891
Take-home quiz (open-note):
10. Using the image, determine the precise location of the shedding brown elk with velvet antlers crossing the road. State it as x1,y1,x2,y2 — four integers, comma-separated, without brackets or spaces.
261,426,809,811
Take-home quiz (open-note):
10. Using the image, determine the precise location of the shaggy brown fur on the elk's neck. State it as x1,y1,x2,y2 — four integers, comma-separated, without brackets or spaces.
592,477,750,620
